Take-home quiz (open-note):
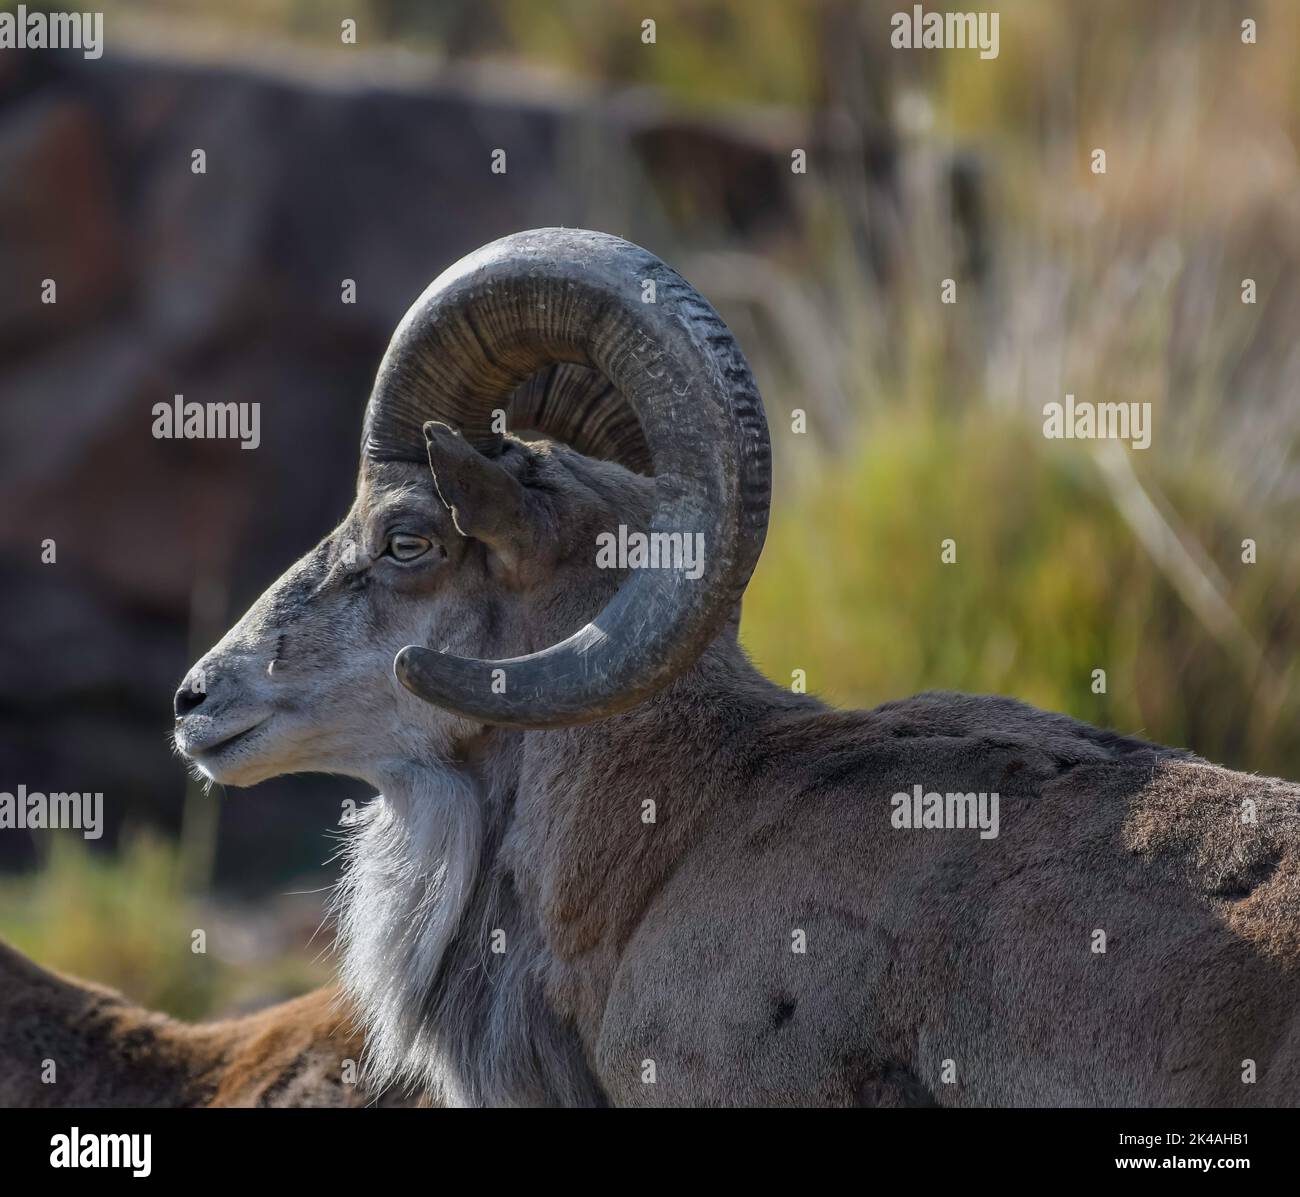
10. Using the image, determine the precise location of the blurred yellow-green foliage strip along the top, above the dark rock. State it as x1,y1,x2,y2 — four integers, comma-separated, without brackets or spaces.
101,0,1300,137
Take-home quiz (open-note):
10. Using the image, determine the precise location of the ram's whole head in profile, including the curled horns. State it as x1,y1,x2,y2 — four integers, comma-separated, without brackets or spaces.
176,229,771,788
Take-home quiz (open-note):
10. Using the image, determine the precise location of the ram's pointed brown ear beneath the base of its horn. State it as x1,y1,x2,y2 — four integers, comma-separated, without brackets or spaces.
424,420,538,576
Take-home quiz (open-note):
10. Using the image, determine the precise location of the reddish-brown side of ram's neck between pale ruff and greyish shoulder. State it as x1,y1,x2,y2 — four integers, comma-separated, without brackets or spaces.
503,637,822,1025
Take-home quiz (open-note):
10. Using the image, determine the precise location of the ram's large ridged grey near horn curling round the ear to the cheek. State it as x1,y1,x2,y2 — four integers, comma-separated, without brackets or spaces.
365,229,771,728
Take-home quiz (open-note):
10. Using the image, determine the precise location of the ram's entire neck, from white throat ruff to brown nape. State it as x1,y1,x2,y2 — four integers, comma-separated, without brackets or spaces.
338,638,818,1105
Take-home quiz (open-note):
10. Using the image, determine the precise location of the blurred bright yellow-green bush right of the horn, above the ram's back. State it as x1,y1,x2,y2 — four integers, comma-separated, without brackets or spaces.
741,408,1300,776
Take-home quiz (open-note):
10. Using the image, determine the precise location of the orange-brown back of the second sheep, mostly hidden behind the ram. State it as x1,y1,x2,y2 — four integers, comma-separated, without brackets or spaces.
0,942,407,1109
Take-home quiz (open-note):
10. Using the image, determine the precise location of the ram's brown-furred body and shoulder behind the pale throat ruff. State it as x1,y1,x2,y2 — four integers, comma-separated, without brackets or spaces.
530,670,1300,1106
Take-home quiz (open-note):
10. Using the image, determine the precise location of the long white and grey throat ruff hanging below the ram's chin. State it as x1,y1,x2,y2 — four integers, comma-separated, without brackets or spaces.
337,733,601,1105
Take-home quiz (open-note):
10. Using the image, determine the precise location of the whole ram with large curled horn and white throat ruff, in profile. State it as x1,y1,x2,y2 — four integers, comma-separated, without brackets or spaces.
176,229,1300,1106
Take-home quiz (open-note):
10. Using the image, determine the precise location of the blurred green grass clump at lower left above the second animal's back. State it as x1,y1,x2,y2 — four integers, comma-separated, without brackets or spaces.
0,832,330,1018
